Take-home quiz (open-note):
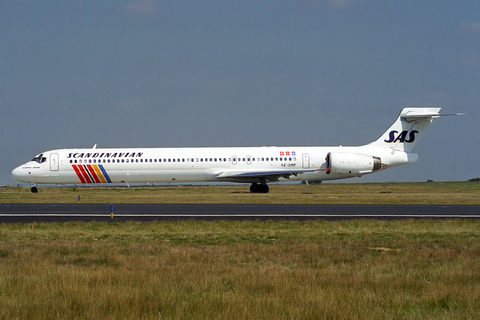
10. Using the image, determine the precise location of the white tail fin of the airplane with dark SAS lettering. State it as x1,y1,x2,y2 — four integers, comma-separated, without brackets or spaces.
369,107,441,153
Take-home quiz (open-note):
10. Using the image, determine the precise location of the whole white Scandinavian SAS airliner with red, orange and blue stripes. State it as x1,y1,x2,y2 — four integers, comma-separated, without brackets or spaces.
12,107,462,193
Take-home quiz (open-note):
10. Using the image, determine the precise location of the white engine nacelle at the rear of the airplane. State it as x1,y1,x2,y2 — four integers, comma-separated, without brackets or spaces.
325,152,382,175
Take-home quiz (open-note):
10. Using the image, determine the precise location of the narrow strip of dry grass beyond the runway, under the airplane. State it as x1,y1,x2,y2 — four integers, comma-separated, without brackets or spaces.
0,182,480,204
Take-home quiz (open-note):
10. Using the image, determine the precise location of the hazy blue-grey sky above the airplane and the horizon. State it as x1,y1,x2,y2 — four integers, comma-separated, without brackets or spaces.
0,0,480,184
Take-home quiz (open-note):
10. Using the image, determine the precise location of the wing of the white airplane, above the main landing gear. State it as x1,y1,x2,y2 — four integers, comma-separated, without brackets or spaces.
217,168,319,182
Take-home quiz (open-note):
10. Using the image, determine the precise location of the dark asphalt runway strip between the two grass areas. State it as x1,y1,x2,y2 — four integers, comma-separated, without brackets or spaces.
0,203,480,223
